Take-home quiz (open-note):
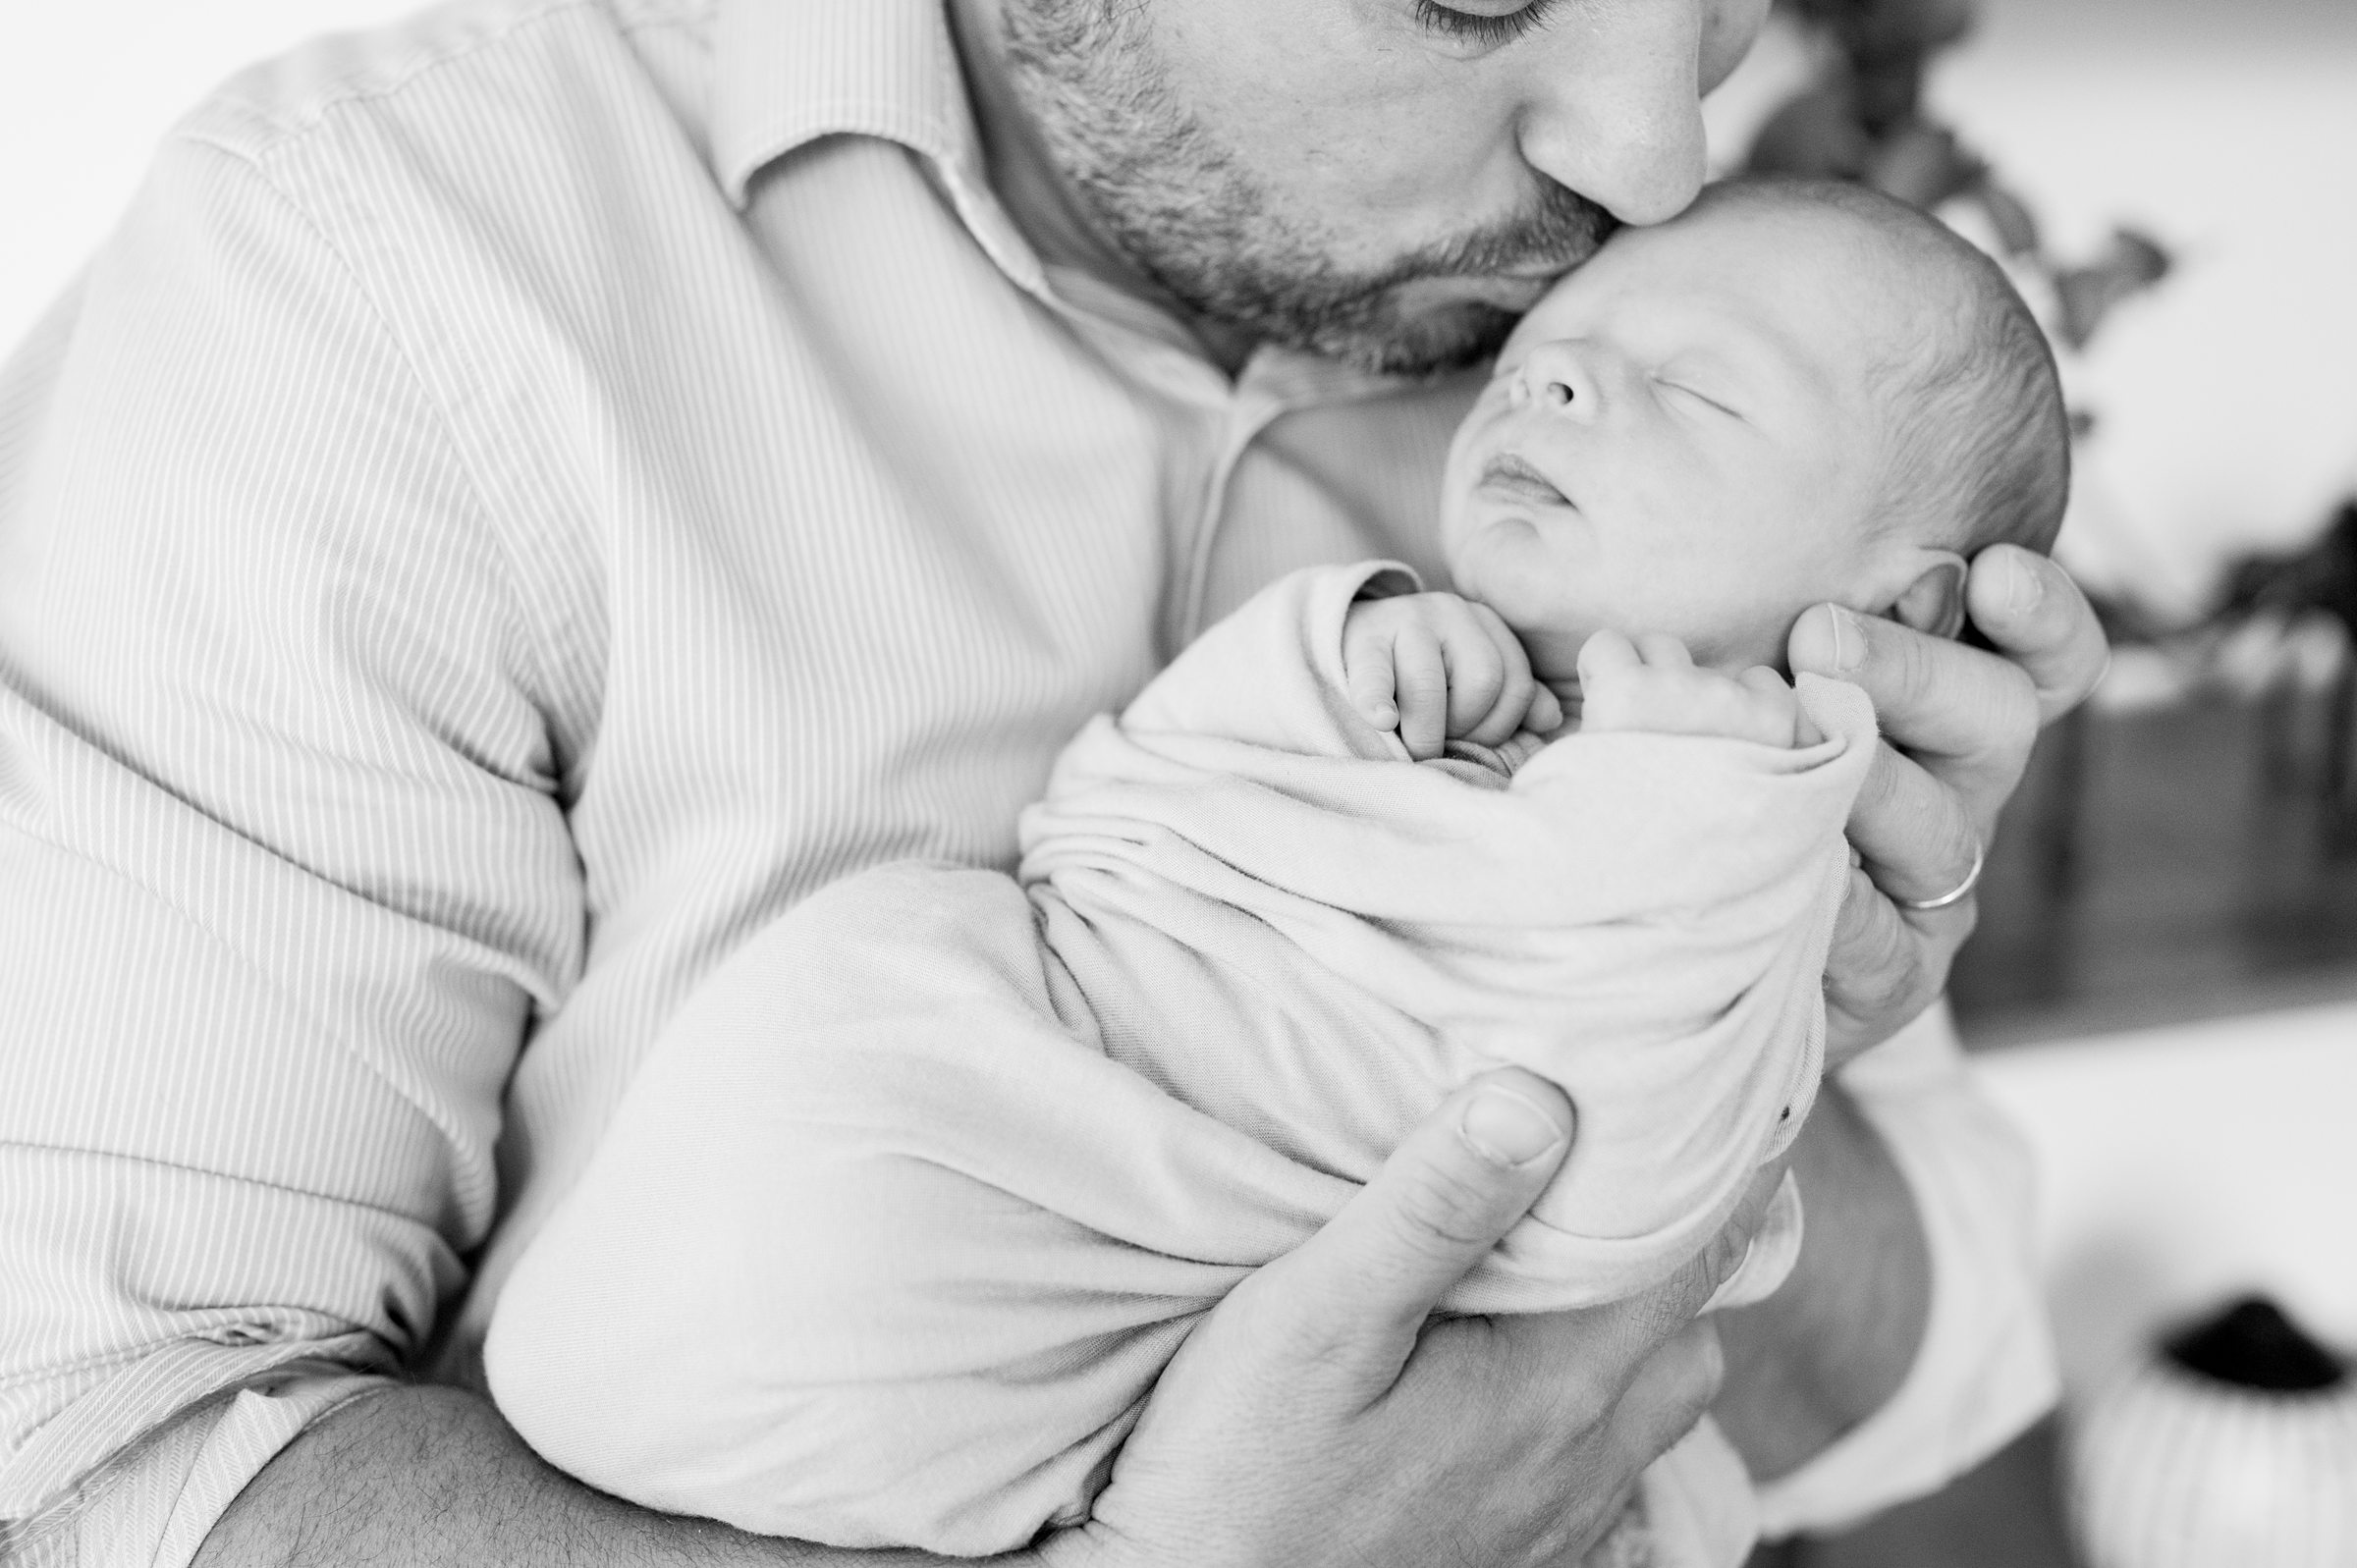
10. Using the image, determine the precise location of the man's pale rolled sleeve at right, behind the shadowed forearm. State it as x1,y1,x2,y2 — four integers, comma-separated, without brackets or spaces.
1758,1002,2060,1538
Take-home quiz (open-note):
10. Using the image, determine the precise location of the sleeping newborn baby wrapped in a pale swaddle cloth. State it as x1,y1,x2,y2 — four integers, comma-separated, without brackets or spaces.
488,184,2067,1563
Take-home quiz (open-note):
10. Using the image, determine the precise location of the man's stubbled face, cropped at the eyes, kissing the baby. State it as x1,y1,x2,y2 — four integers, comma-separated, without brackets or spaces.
1004,0,1768,370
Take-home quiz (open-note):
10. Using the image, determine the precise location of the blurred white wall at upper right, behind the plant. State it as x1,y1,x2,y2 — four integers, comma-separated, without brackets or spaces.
1933,0,2357,609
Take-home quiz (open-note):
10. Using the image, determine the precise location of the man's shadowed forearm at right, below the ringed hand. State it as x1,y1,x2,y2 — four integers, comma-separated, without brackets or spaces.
1711,1085,1931,1481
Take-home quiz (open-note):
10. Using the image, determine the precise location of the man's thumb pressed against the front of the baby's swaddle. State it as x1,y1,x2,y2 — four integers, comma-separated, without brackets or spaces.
1285,1068,1572,1361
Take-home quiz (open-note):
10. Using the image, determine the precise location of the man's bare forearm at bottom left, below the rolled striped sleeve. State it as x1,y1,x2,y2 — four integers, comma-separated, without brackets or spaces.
195,1386,994,1568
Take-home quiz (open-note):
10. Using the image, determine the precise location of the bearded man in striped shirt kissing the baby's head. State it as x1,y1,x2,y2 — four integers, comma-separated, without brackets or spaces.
0,0,2103,1563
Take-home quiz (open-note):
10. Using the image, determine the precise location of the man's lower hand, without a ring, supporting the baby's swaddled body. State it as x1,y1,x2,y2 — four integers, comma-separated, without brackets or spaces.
1039,1068,1780,1568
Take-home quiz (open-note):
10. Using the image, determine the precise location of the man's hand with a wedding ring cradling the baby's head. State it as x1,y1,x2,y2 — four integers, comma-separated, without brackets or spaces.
1786,545,2110,1068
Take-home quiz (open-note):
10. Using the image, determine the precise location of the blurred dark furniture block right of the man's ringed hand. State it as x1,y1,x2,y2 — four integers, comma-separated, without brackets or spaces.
1949,670,2357,1050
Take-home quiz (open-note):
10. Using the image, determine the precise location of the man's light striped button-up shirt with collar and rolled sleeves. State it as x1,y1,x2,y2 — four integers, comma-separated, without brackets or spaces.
0,0,2046,1563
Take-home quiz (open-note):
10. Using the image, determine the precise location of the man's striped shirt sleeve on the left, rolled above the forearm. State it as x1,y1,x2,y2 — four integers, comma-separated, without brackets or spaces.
0,135,584,1563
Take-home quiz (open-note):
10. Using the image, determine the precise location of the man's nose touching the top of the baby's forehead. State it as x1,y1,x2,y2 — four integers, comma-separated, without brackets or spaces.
1518,0,1714,224
